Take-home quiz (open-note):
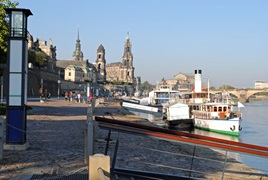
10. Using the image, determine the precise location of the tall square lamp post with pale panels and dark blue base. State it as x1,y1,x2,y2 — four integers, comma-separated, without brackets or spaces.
5,8,32,150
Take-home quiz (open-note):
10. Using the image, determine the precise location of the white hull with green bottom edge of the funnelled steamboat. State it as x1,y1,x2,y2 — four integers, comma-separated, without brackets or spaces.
194,117,241,136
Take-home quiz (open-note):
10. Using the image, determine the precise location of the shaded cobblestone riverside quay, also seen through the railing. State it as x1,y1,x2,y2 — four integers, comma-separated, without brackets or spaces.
0,99,268,179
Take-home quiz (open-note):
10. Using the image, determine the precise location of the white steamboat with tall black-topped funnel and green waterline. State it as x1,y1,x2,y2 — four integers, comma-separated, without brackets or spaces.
189,70,244,136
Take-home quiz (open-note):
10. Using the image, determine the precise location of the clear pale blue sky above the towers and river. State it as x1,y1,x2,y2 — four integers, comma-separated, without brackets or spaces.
18,0,268,88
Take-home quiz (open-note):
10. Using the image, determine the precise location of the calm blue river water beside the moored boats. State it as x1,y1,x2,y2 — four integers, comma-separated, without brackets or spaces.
127,102,268,174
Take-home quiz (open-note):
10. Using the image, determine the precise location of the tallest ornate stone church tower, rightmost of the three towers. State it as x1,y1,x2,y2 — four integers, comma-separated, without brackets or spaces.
121,33,135,83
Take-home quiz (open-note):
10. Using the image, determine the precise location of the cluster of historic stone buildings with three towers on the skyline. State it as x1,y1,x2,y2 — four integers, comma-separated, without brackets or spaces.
56,31,141,95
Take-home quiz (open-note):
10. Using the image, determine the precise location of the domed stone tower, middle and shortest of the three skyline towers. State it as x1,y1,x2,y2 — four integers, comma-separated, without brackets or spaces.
96,44,106,82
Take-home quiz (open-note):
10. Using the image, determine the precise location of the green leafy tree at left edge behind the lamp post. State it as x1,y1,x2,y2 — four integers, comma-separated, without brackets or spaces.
0,0,19,63
